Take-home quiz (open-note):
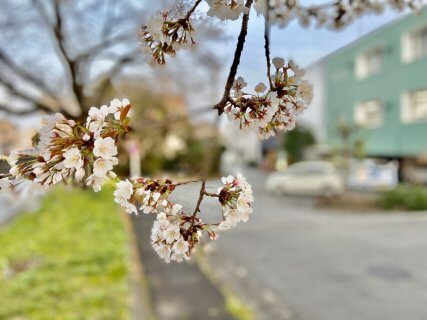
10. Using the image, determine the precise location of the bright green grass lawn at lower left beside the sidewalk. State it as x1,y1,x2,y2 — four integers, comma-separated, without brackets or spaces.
0,188,130,320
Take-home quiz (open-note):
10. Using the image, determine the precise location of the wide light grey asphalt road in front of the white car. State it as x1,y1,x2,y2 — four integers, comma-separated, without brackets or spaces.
209,171,427,320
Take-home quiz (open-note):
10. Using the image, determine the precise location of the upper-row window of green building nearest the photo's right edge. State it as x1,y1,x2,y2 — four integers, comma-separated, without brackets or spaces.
402,26,427,62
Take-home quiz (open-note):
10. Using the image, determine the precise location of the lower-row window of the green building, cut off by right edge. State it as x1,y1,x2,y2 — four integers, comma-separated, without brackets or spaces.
401,89,427,123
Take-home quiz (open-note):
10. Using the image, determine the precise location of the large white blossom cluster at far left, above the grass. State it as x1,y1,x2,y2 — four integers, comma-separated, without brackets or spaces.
9,99,130,191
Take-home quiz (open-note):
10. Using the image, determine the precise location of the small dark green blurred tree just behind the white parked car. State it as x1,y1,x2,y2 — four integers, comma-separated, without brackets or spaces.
283,125,316,163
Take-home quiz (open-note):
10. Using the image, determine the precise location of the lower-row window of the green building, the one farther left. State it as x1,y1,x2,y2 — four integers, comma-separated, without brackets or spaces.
354,100,384,128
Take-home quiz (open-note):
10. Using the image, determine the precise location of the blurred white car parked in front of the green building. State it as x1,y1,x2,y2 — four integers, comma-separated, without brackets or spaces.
266,161,344,197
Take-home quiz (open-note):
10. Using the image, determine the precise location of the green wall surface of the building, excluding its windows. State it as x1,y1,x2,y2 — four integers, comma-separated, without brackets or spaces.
324,9,427,157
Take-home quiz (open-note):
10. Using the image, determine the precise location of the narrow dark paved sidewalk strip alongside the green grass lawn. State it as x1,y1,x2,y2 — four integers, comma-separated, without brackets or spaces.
132,214,233,320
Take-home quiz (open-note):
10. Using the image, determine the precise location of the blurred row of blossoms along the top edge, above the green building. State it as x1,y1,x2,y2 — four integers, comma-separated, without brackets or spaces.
254,0,422,29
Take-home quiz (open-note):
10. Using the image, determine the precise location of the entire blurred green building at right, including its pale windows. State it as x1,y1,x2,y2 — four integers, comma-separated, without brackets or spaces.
308,8,427,180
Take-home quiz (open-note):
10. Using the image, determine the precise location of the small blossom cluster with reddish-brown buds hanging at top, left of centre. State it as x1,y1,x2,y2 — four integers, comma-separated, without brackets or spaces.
141,12,195,64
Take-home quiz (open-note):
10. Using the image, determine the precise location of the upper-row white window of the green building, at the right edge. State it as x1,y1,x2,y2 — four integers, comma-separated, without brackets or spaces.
401,25,427,63
